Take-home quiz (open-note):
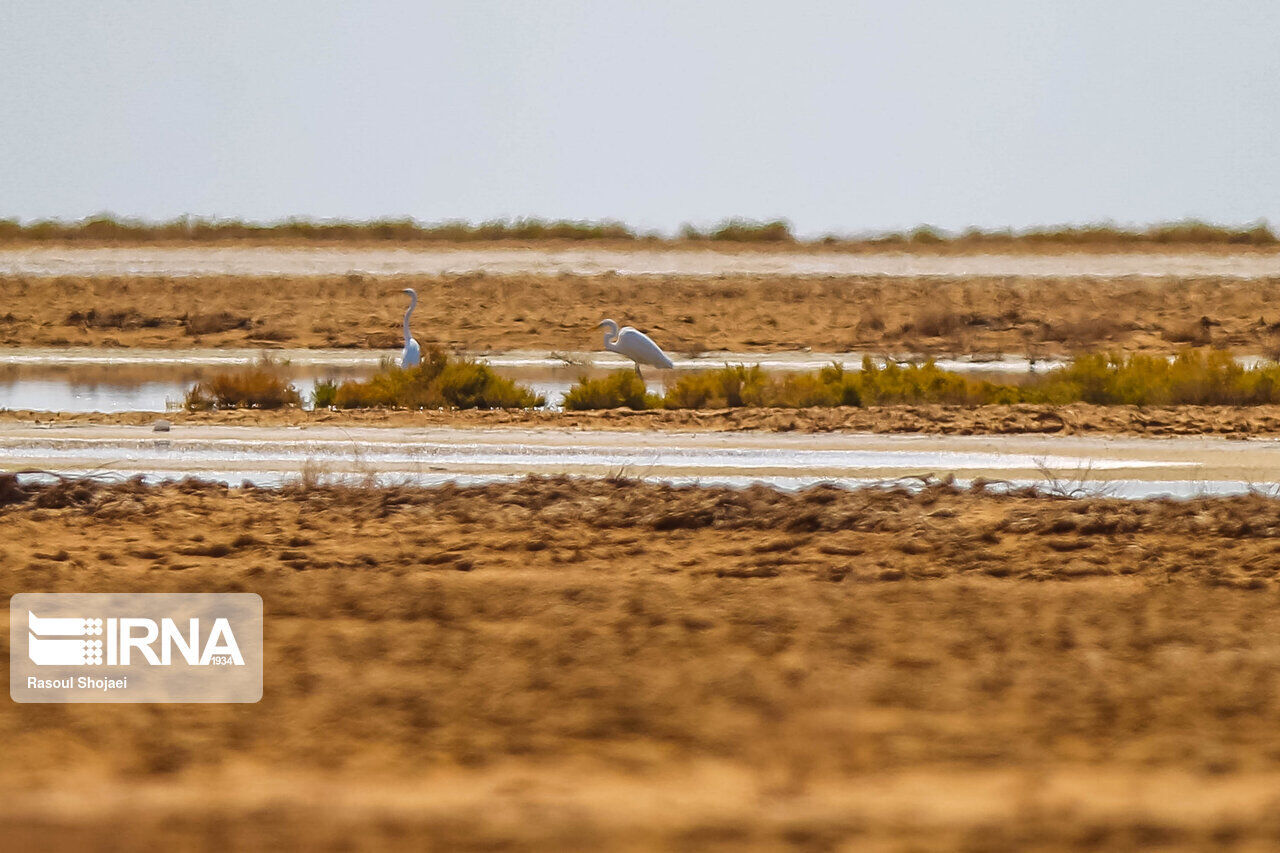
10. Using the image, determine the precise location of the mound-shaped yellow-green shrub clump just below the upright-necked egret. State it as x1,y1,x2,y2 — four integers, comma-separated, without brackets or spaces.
317,347,547,409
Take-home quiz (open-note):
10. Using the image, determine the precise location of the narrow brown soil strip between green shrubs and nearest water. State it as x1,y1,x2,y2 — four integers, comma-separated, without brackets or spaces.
0,403,1280,438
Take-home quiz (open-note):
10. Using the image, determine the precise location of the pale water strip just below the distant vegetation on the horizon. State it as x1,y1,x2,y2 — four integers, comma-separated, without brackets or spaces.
0,246,1280,278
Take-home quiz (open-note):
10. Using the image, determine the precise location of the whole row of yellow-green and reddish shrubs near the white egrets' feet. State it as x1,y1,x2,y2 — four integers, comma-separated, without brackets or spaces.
184,347,1280,411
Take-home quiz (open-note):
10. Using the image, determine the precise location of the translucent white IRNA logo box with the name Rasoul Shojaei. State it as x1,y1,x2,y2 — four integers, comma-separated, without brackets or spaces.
9,593,262,702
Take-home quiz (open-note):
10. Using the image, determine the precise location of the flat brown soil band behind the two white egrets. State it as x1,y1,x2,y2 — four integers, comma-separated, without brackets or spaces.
0,274,1280,357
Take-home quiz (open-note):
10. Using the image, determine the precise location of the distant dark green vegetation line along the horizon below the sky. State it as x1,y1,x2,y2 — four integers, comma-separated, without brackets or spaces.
0,214,1280,248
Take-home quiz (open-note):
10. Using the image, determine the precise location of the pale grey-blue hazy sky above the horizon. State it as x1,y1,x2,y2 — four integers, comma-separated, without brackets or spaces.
0,0,1280,233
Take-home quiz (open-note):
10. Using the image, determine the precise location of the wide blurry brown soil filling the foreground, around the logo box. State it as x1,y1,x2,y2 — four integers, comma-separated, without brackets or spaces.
0,479,1280,850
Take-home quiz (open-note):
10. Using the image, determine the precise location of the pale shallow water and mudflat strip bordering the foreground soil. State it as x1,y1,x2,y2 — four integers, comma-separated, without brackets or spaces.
0,424,1280,497
